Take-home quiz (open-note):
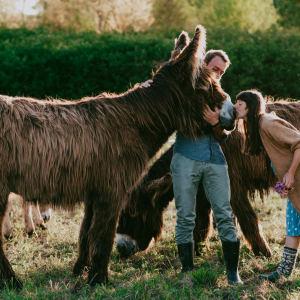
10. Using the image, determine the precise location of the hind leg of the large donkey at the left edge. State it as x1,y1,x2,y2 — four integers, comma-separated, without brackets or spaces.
0,182,22,289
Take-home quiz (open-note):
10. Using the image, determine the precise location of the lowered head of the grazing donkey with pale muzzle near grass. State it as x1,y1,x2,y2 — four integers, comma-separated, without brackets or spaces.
117,173,173,257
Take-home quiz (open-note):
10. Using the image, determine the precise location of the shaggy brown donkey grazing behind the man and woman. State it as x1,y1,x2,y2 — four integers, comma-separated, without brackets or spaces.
117,101,300,256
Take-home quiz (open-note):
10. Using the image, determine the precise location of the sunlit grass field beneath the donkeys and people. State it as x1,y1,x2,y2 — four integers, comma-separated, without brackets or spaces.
0,194,300,300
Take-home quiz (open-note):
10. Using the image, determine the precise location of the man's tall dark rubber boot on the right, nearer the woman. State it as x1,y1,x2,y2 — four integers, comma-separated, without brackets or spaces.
222,239,243,285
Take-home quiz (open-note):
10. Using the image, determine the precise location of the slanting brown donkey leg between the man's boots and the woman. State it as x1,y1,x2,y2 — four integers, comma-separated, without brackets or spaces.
231,193,272,257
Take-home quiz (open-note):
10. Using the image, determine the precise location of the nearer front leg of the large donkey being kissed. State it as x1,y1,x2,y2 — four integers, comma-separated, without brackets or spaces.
88,199,121,286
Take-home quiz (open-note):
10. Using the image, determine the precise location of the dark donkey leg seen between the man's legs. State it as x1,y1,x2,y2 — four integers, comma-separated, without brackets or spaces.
194,183,212,256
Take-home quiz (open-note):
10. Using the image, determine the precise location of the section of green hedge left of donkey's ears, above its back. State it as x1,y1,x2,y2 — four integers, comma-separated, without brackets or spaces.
0,29,172,99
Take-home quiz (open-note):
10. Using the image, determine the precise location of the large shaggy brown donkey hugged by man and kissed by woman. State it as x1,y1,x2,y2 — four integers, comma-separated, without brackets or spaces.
0,26,235,287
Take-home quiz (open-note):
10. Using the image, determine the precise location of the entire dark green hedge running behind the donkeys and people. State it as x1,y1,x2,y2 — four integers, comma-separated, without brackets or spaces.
0,27,300,99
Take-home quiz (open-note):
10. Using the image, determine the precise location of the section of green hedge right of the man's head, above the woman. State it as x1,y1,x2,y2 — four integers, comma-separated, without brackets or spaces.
208,28,300,99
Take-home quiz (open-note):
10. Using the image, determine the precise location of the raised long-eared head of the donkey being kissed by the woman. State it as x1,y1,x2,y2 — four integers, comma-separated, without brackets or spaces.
154,25,235,136
